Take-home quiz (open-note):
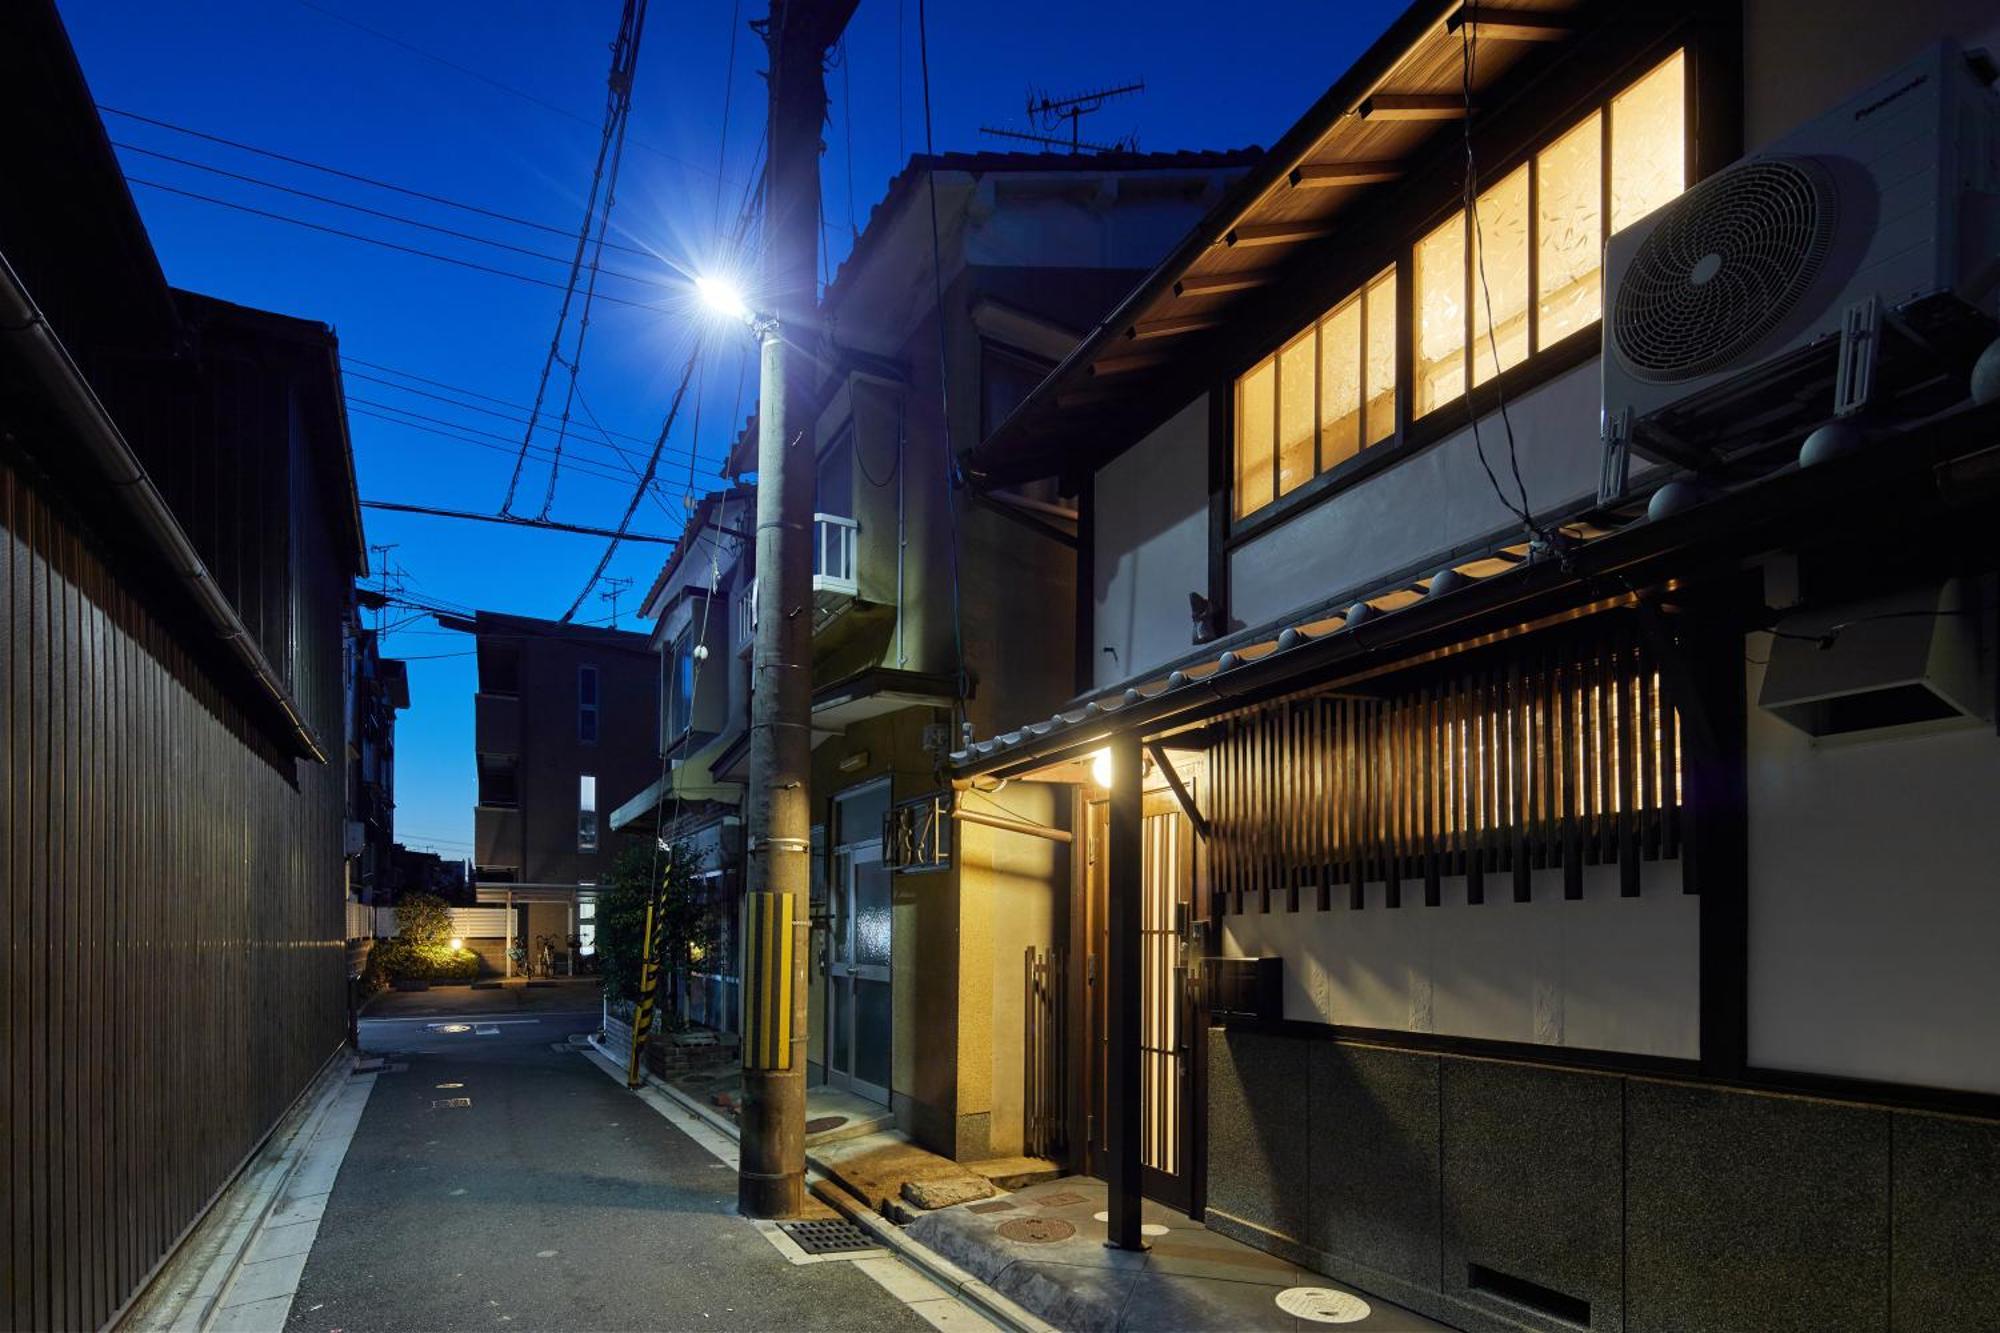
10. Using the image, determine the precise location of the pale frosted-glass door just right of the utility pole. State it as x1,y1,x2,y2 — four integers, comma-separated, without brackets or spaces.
826,783,894,1105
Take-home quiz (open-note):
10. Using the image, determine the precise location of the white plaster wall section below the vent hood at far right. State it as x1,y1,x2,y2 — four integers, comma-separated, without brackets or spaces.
1746,634,2000,1093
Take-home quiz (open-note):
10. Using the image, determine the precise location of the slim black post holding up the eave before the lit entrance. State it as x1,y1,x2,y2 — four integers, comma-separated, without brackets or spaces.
1104,733,1146,1249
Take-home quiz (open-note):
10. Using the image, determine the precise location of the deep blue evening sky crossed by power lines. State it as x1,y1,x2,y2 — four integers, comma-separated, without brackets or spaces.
62,0,1400,857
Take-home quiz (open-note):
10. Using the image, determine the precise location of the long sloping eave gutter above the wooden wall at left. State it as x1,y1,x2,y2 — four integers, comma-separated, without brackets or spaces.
0,256,326,765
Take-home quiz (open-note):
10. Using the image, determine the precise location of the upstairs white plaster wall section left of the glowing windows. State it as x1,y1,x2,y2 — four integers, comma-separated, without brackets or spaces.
1092,394,1208,687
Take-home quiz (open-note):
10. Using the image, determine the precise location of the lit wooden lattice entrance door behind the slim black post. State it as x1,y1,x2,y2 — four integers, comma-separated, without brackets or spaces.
1084,793,1198,1213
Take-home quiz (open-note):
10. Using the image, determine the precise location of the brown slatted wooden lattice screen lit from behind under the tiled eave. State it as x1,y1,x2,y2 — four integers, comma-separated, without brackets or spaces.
1208,612,1680,913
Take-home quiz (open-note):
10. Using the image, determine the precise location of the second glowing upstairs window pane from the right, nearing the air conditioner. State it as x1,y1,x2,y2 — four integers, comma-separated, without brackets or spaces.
1534,114,1604,346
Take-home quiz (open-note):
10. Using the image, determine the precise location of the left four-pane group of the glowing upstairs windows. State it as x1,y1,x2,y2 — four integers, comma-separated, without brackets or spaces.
1236,268,1396,518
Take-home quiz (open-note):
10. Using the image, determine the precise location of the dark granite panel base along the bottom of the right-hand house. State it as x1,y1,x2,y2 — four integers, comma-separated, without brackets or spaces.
1208,1029,2000,1333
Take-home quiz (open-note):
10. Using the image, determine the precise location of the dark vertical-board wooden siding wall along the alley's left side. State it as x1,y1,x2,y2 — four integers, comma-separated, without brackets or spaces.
0,452,346,1329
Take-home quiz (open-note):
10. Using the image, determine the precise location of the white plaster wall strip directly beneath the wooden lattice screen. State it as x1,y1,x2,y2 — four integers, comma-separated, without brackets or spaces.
1222,861,1700,1059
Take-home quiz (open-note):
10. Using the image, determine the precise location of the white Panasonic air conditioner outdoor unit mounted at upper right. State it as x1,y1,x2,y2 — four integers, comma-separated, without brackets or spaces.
1602,42,2000,500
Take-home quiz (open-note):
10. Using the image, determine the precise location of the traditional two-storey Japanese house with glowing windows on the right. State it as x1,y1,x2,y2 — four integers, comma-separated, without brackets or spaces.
952,0,2000,1329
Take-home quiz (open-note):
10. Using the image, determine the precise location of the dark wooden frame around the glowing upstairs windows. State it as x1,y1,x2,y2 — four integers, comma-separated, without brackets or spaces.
1210,33,1696,548
